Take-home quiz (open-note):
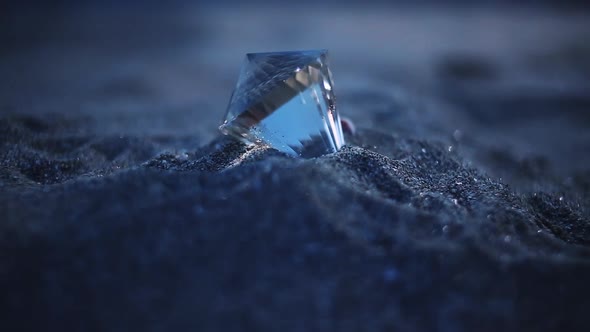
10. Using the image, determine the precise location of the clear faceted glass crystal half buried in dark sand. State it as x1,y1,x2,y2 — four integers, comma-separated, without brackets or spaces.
219,50,344,157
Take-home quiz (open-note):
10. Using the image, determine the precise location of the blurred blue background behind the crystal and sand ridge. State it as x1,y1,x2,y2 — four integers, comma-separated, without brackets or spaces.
0,0,590,181
